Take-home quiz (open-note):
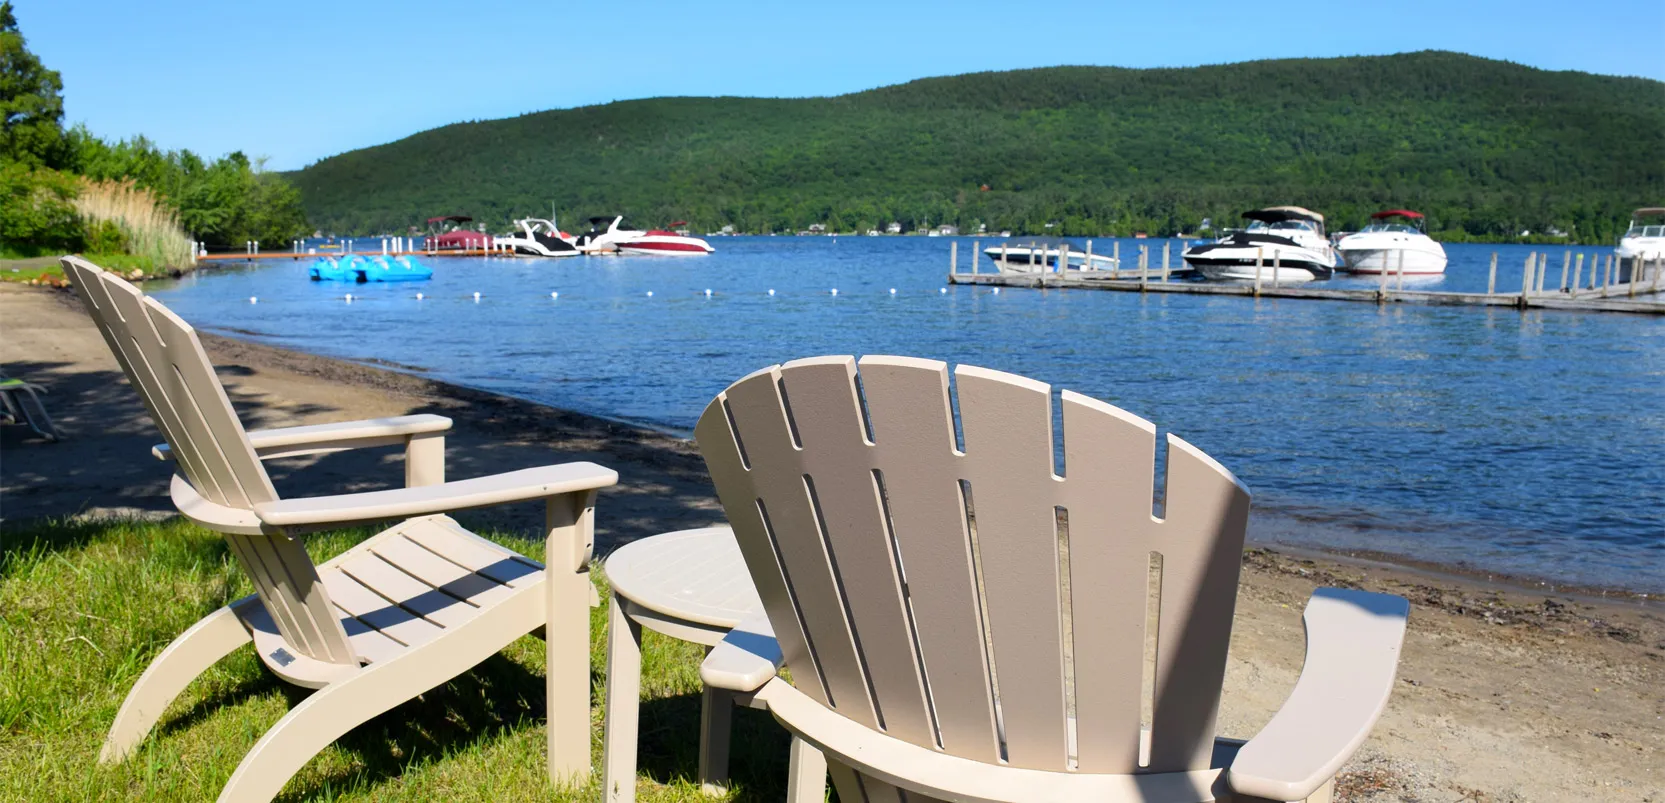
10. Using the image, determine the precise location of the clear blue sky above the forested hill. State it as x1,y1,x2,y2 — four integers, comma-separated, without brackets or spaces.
15,0,1665,170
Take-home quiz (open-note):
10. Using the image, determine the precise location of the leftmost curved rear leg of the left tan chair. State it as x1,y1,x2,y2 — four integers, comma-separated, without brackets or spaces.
98,598,258,763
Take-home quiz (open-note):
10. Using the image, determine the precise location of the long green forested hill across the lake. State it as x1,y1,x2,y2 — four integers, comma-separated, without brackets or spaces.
291,52,1665,242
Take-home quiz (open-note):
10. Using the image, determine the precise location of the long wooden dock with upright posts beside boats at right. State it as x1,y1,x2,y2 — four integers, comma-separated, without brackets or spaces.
947,243,1665,315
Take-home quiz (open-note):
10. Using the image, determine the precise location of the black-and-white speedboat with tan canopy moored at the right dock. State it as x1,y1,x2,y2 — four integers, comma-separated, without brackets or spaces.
1184,207,1335,282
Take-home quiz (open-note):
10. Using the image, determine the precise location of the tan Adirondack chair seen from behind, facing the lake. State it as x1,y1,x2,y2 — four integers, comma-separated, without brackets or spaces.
694,357,1409,803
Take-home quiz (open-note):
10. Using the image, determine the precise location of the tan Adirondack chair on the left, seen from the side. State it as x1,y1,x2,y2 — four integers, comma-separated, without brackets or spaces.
63,257,618,801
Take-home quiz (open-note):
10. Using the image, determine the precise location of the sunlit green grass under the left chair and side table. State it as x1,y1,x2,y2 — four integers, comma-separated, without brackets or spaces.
0,518,788,801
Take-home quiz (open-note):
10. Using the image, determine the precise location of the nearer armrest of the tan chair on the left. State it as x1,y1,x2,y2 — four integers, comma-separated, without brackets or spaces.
255,463,619,526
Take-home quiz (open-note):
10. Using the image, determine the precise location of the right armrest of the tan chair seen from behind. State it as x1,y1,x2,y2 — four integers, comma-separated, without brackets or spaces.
1227,588,1410,800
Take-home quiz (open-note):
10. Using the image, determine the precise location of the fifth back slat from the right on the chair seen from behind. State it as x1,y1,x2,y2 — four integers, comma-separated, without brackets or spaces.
781,357,936,746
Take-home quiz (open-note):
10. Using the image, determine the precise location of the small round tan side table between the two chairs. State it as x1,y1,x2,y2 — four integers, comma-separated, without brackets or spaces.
601,526,826,803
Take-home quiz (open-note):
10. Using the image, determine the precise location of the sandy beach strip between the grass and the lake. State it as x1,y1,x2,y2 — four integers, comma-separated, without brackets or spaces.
0,285,1665,803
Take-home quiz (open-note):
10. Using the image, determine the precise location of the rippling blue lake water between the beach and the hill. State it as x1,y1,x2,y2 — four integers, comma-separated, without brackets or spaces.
148,237,1665,593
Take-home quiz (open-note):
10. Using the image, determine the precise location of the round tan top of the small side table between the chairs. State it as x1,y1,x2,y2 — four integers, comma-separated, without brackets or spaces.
604,526,763,630
